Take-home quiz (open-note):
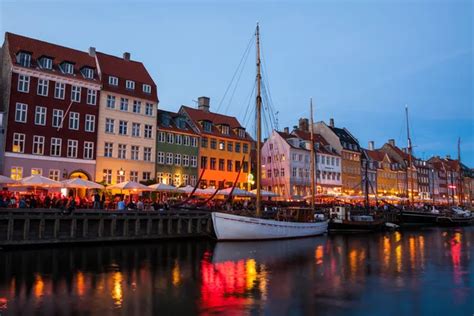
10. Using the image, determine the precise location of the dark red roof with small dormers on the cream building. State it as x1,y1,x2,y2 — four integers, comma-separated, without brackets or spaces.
96,52,158,102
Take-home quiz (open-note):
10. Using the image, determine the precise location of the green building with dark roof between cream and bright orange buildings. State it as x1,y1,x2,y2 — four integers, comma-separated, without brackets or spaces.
156,110,199,187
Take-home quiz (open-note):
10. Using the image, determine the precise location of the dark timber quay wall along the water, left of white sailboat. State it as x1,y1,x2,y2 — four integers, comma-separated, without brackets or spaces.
0,209,212,248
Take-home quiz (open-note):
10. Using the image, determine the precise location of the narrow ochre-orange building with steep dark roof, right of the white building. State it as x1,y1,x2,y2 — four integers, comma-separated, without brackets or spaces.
313,119,362,195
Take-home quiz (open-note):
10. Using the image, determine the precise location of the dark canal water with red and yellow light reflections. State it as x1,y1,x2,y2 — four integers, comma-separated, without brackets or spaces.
0,227,474,316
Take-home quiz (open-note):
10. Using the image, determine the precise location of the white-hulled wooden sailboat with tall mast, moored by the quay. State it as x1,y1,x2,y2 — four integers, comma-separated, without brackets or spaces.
211,24,328,241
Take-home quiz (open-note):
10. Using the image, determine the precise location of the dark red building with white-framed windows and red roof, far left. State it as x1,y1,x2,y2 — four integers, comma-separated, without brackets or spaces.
0,32,101,180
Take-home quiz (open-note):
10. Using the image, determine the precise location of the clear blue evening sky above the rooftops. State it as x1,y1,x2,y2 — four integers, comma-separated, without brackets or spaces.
0,0,474,167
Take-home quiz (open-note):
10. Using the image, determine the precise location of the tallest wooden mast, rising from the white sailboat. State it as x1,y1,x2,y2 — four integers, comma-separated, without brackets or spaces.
255,23,262,216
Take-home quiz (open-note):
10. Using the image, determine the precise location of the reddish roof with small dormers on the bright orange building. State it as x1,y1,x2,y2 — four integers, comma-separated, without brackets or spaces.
181,105,252,141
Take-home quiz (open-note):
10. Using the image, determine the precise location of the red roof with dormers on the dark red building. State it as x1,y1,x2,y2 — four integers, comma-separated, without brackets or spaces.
5,32,98,82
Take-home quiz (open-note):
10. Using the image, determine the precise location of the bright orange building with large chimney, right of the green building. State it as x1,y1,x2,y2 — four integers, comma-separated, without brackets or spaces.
179,97,252,189
